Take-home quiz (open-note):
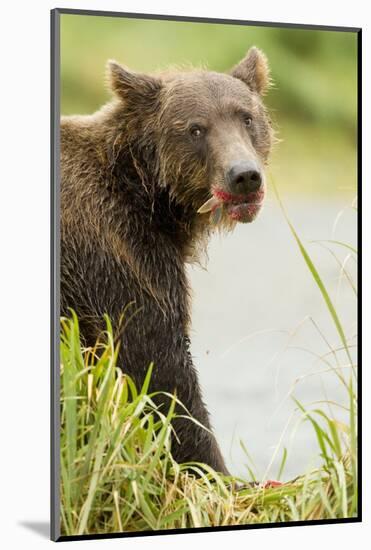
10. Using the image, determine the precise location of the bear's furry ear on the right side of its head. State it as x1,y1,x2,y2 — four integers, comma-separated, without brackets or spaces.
229,46,270,95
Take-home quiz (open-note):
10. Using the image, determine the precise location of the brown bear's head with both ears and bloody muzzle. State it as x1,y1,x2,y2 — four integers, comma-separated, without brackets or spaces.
108,47,273,225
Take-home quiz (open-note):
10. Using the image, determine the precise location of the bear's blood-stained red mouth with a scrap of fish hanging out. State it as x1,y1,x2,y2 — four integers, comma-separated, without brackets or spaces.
198,188,265,223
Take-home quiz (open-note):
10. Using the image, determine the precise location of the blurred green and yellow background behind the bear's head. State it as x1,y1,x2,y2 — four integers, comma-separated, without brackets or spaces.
61,15,357,197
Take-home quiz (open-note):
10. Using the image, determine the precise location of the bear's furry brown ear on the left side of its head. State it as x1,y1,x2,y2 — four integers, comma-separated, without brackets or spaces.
107,60,162,101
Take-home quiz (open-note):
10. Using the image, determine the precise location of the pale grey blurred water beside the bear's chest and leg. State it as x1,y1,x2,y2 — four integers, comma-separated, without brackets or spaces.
189,197,356,479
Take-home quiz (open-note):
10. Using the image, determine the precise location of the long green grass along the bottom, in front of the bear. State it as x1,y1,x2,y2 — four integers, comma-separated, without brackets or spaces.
60,272,358,535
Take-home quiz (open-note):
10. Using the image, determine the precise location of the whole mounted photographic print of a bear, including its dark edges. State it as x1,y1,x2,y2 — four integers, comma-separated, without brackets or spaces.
51,9,361,540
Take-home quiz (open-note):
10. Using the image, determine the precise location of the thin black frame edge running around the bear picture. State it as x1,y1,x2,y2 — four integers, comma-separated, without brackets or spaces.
50,8,362,542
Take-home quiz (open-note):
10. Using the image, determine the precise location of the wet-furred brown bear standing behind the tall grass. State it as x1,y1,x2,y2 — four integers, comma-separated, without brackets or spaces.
61,47,273,474
